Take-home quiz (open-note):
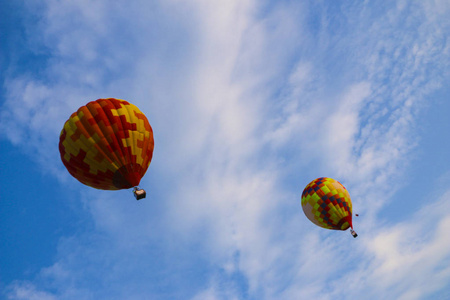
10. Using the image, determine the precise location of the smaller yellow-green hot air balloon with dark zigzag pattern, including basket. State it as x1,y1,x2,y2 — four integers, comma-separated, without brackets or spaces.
302,177,358,237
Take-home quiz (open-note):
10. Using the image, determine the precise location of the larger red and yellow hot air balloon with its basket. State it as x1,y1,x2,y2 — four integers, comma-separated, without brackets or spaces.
59,98,154,200
